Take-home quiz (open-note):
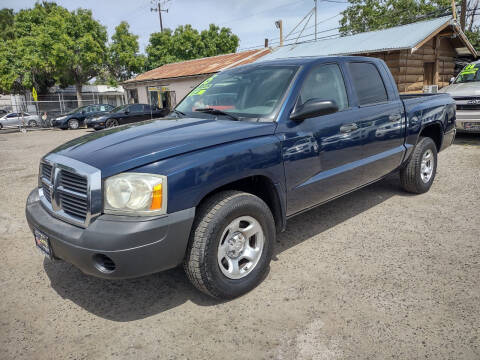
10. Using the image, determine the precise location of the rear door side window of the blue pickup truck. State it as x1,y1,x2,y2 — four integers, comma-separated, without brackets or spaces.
348,62,388,105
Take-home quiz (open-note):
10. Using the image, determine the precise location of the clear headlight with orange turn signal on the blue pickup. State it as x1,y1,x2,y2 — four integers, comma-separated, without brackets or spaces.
104,173,167,215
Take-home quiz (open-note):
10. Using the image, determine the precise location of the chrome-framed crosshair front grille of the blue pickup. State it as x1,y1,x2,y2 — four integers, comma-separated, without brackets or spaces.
39,154,102,227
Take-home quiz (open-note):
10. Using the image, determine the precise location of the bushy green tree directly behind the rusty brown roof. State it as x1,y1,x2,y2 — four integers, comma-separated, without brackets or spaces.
146,24,239,69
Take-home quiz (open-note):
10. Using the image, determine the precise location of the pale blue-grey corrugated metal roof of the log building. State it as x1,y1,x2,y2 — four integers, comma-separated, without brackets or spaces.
261,16,453,61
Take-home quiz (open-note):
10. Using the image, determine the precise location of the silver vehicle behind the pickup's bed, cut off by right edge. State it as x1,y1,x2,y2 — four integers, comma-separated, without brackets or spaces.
439,61,480,133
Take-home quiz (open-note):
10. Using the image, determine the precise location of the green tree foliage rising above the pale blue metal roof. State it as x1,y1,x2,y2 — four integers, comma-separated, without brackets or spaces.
339,0,451,35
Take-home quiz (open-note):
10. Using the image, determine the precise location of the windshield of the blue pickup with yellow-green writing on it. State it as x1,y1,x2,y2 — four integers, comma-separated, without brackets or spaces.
175,66,298,119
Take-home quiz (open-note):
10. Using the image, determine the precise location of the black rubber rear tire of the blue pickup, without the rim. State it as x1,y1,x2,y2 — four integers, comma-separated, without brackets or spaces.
400,137,437,194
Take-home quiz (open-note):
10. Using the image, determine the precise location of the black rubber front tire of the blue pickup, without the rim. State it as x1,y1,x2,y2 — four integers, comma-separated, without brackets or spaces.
184,191,276,299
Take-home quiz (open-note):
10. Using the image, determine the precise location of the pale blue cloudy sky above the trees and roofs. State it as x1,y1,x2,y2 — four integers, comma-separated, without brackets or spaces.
0,0,347,52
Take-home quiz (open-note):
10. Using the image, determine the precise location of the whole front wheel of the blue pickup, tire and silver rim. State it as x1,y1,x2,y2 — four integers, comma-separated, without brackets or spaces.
184,191,276,299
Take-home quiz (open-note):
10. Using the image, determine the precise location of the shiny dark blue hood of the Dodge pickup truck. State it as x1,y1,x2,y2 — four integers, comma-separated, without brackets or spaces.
52,118,276,177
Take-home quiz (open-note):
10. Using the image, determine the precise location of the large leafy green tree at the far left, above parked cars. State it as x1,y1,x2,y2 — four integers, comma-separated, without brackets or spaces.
0,2,107,102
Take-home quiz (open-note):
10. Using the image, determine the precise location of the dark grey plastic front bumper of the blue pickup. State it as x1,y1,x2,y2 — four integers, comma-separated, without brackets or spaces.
25,189,195,279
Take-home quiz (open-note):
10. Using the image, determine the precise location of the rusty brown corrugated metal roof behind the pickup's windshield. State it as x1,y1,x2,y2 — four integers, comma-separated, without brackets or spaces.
125,49,270,83
